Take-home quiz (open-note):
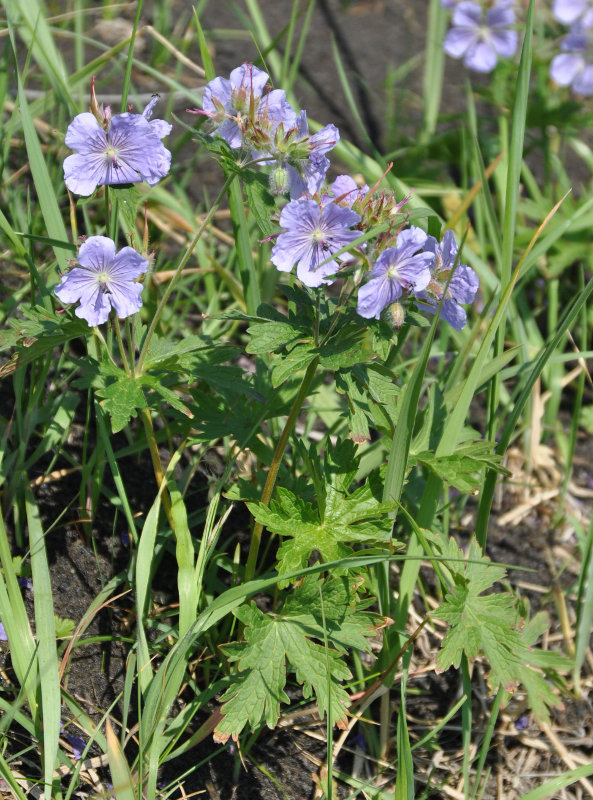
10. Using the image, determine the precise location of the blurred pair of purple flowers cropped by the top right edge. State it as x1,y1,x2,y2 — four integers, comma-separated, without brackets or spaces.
550,0,593,96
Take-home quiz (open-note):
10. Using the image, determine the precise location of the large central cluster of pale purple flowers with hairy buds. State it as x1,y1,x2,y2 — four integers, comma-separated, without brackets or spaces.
196,61,476,328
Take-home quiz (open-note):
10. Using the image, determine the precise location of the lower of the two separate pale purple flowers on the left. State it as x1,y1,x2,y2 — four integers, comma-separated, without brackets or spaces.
54,236,148,326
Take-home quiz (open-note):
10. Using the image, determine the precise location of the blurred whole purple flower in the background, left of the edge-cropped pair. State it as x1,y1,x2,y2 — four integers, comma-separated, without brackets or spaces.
443,0,519,72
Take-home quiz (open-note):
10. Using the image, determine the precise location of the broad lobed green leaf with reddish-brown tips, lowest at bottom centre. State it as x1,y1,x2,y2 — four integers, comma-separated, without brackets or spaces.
215,576,385,741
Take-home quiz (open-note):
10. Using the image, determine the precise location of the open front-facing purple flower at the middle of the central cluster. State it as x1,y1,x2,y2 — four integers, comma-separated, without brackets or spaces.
271,197,360,286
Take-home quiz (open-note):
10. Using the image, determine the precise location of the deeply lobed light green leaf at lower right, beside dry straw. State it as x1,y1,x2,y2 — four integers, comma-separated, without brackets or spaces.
429,535,571,721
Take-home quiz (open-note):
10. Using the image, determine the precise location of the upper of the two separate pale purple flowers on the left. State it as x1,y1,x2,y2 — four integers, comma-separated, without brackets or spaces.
64,97,172,196
